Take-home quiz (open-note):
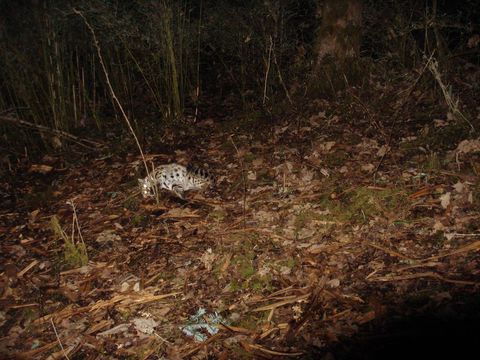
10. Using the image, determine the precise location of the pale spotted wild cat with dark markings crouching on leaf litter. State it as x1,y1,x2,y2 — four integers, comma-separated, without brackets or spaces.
138,164,214,199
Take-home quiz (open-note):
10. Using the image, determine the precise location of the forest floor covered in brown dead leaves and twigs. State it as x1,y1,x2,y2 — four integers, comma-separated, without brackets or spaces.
0,71,480,359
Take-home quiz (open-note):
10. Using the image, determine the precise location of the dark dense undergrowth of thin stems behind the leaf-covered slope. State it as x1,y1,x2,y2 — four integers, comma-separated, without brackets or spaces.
0,0,479,159
